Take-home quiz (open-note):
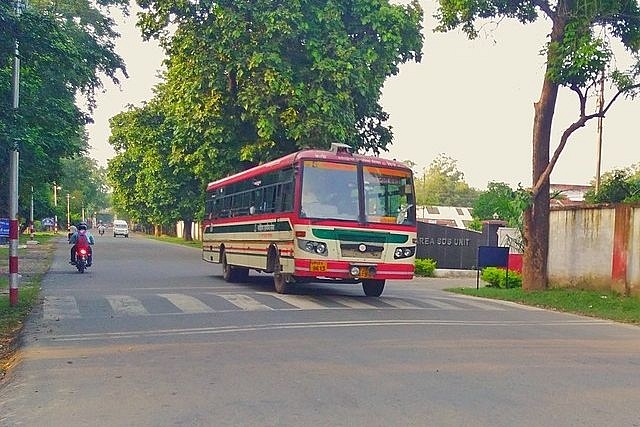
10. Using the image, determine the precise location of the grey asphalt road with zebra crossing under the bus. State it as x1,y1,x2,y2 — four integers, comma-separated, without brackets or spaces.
0,235,640,427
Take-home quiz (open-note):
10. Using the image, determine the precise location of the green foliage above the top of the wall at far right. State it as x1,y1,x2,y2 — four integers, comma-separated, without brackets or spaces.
585,164,640,203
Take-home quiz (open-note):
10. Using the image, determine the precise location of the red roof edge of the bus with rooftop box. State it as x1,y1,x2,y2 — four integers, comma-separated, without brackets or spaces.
207,144,410,191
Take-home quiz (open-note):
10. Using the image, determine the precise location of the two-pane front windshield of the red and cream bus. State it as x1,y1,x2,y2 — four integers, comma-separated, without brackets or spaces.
300,161,415,224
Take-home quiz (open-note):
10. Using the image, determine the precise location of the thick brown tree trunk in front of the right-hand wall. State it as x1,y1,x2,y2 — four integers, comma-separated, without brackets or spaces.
522,21,564,290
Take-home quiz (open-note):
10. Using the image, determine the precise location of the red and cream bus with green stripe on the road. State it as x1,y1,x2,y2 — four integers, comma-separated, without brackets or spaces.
202,143,417,297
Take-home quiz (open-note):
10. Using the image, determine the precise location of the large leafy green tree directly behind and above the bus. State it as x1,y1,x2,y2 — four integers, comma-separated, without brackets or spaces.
138,0,422,179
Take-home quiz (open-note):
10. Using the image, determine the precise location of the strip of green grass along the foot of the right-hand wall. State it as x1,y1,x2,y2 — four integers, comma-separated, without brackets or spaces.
447,287,640,325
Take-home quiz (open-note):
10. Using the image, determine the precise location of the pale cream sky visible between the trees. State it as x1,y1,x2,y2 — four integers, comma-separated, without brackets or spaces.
87,0,640,190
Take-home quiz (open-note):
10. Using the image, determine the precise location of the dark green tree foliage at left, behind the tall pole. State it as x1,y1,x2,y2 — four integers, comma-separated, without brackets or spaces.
0,0,128,217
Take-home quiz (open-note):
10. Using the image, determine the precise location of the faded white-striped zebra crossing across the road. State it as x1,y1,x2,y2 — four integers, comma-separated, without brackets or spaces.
42,292,506,320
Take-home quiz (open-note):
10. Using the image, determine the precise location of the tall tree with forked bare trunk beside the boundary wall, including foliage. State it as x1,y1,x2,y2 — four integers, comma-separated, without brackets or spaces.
436,0,640,290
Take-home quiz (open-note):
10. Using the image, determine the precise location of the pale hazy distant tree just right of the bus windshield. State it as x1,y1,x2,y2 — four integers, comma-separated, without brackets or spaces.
416,153,478,207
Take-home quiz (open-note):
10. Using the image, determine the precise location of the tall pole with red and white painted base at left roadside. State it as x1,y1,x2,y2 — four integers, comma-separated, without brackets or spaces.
9,0,25,306
